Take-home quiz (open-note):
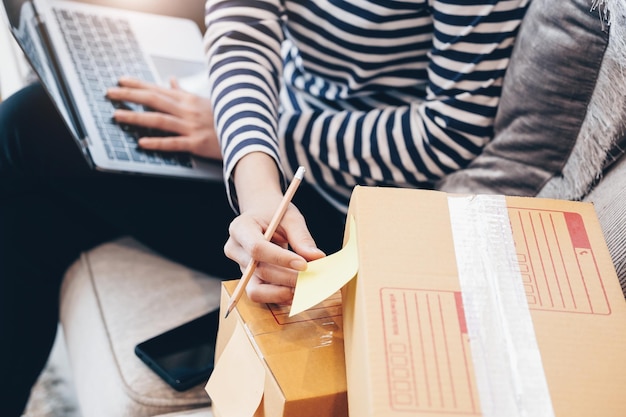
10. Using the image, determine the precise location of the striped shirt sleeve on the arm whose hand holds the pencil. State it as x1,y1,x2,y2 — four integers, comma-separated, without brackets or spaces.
205,0,286,209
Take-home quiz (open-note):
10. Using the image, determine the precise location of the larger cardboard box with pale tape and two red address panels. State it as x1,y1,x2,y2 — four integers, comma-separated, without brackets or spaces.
342,187,626,417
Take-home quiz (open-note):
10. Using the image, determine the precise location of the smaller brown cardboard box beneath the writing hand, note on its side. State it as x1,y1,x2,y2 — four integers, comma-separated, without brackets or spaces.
207,280,348,417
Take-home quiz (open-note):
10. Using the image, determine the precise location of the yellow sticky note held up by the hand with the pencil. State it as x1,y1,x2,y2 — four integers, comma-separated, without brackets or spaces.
289,218,359,317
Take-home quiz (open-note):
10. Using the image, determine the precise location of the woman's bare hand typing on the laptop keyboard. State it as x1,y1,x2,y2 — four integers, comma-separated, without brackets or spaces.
106,77,221,160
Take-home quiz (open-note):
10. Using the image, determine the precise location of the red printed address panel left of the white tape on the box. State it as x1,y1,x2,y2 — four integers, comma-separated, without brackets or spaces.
380,288,480,415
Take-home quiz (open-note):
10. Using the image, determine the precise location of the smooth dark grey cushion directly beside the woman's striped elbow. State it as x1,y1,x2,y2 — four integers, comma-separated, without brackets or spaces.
437,0,608,196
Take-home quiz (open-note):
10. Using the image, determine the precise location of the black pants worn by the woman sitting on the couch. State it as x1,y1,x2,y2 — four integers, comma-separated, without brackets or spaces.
0,84,344,417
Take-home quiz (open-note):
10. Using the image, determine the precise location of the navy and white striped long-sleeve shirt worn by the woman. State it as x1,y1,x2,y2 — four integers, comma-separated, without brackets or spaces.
205,0,530,210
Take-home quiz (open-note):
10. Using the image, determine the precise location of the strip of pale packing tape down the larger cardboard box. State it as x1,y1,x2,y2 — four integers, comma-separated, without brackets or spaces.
448,195,554,417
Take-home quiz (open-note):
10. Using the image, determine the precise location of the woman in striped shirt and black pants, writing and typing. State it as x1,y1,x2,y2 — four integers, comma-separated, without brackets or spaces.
0,0,527,416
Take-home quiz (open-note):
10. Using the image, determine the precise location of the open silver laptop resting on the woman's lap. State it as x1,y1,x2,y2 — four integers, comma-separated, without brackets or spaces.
3,0,223,181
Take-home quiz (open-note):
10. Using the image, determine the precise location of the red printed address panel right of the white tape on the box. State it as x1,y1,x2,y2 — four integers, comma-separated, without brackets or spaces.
509,207,610,314
